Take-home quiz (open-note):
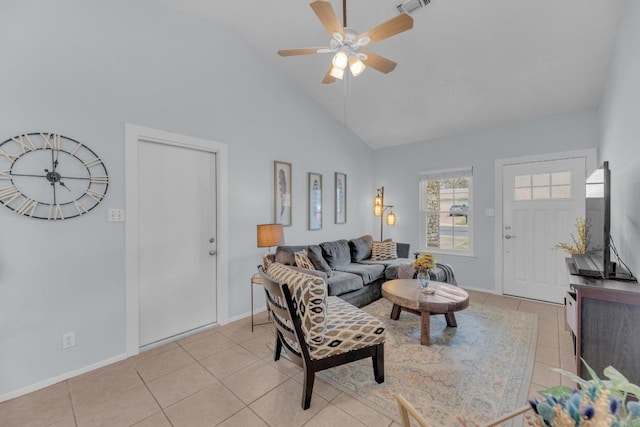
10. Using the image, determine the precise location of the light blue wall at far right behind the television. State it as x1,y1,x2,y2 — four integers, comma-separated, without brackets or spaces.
600,0,640,277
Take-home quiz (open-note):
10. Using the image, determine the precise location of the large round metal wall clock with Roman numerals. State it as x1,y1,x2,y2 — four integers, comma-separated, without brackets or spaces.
0,132,109,220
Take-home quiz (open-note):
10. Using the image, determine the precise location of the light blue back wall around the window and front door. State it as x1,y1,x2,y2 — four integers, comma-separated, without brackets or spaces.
375,110,599,291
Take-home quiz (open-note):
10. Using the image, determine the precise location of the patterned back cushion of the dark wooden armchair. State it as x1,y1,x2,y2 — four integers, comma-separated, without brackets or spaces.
267,262,327,345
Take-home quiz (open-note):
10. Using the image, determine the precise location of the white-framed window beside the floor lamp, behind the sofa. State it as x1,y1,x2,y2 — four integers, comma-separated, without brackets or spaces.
419,167,473,255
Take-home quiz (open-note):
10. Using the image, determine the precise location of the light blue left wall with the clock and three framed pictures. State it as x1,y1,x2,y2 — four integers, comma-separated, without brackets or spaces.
0,0,375,400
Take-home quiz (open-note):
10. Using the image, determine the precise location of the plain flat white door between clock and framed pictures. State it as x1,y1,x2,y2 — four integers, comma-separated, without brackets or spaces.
137,141,217,347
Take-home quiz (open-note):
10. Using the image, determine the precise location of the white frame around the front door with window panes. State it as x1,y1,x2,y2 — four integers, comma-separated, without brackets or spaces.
493,148,598,295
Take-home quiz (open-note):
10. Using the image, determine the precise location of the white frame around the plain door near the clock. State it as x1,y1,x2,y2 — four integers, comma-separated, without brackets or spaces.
124,123,229,357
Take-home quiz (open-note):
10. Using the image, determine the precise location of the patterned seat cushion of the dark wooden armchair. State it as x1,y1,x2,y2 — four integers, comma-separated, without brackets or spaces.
309,297,385,359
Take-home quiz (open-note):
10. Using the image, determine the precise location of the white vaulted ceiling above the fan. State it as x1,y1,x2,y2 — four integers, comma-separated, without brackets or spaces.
147,0,625,148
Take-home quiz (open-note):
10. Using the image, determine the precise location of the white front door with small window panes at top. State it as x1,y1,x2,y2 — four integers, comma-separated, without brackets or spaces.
502,157,586,303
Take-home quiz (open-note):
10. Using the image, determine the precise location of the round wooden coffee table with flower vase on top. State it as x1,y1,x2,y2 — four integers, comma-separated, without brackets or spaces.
382,279,469,345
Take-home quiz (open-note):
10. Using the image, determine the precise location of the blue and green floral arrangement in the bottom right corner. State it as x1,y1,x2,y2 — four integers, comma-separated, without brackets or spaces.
529,360,640,427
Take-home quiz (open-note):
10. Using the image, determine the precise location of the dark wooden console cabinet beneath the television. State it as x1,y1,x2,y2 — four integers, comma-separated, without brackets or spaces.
565,259,640,384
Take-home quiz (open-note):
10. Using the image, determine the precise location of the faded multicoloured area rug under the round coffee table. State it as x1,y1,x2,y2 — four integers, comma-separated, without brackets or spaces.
318,299,538,427
